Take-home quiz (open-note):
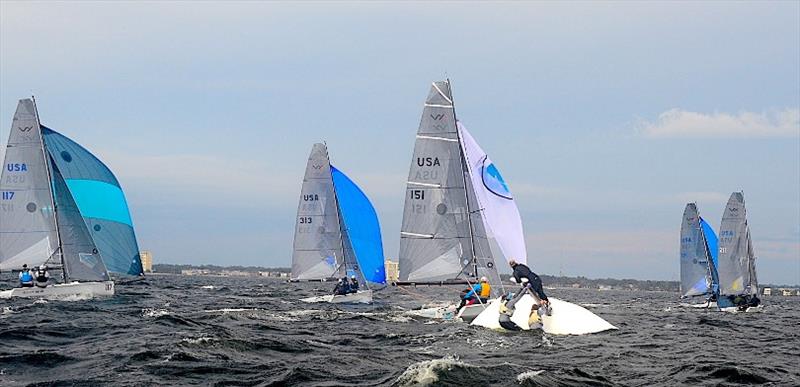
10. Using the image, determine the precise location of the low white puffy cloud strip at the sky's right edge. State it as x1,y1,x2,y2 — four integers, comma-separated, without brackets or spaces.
637,108,800,138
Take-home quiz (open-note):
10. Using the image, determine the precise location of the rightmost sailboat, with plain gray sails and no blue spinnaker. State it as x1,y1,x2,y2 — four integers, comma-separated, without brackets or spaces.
717,192,762,312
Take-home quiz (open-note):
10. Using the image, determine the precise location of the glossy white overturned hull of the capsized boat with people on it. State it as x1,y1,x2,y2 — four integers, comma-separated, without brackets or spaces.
471,294,617,335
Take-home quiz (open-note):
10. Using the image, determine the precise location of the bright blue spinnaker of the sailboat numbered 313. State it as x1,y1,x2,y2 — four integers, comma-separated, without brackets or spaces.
331,166,386,284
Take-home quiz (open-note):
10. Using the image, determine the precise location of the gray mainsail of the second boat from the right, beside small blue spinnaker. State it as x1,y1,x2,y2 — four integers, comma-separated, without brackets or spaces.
680,203,712,297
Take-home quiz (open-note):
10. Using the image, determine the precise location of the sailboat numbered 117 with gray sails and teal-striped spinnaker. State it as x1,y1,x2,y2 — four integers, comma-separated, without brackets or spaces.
0,99,142,298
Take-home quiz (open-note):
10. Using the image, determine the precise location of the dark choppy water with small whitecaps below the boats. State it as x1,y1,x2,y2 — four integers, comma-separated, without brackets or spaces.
0,276,800,386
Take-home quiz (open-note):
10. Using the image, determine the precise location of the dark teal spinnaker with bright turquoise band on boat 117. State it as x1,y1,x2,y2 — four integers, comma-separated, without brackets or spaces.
42,126,143,276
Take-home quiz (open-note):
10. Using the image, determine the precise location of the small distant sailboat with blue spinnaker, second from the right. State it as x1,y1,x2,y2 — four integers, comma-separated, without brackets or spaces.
680,203,719,308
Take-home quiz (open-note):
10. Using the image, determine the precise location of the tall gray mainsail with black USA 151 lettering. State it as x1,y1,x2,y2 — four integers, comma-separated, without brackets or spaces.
399,81,475,281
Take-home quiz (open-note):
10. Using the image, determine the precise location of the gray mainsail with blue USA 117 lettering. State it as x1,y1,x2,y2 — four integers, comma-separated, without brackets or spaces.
0,99,59,270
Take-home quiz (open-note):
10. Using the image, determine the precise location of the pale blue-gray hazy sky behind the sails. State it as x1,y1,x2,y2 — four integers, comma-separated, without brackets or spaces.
0,1,800,284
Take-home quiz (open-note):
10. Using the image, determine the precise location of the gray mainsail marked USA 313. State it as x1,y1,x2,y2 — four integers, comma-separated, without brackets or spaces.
292,144,344,280
